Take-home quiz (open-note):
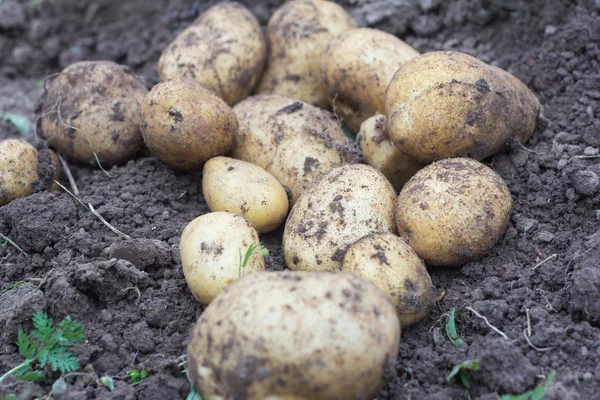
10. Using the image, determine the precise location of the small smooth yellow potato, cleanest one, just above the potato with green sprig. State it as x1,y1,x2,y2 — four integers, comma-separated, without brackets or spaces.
202,157,289,233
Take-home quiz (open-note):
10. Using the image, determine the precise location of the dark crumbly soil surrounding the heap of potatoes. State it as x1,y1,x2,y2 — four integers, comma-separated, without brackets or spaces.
0,0,600,399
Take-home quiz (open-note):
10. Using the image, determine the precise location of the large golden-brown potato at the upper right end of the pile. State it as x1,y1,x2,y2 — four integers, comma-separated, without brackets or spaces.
385,51,540,163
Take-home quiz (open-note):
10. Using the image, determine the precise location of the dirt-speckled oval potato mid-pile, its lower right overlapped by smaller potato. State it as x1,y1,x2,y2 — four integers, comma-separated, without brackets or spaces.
283,164,396,271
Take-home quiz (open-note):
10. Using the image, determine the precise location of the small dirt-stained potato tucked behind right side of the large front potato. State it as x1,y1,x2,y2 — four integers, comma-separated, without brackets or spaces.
342,233,436,328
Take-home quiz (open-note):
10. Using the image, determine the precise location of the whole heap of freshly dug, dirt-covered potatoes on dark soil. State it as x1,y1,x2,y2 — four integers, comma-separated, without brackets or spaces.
0,0,540,400
